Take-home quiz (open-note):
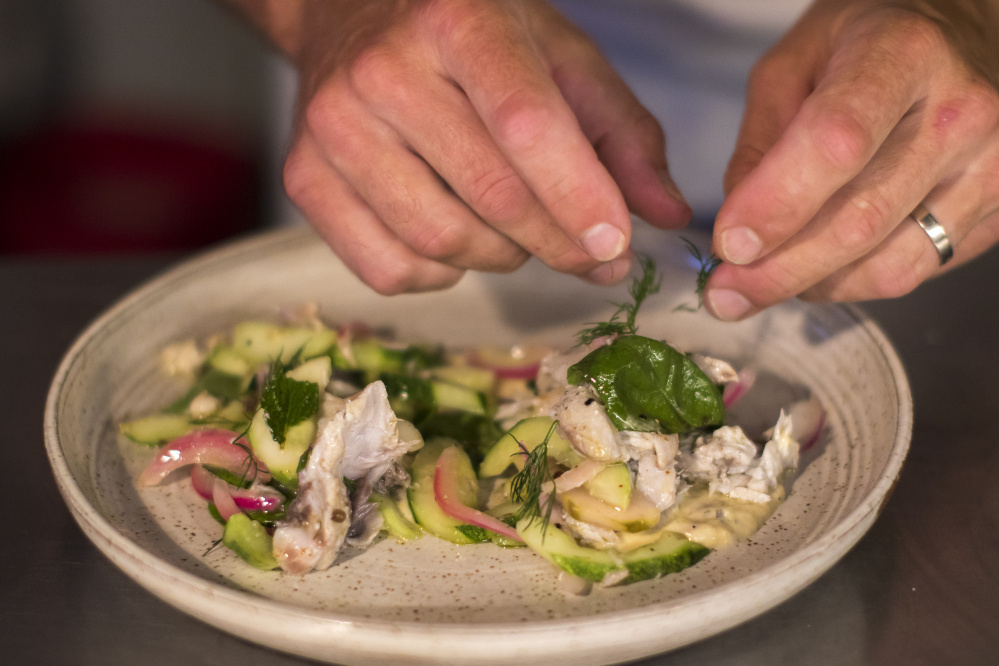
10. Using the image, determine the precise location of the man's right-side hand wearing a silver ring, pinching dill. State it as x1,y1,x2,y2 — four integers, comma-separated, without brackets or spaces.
705,0,999,320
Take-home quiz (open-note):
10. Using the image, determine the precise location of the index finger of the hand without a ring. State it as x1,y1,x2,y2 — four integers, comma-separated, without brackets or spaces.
441,7,631,261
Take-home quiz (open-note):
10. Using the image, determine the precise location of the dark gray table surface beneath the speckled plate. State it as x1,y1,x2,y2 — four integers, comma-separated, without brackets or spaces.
0,246,999,666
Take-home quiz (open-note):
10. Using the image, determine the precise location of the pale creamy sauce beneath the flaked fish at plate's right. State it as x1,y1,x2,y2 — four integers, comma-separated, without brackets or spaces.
666,485,784,550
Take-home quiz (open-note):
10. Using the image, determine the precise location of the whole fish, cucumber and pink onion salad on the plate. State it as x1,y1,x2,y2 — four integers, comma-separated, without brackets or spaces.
120,261,823,593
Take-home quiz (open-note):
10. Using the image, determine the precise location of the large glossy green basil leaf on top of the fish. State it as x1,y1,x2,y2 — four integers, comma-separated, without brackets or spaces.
568,335,725,433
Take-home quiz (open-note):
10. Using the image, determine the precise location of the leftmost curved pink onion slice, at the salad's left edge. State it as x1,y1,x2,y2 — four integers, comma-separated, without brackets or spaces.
139,428,270,486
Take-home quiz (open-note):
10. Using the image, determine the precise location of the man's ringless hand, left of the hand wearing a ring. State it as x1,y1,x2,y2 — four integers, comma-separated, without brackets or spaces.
224,0,690,294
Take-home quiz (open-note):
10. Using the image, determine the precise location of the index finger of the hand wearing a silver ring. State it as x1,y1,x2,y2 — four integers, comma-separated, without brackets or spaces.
715,15,926,264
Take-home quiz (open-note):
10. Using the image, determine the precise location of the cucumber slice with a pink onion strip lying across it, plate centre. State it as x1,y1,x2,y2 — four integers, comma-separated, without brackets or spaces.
407,437,478,544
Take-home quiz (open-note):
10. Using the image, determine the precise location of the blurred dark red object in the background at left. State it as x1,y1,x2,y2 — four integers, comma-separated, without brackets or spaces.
0,121,260,254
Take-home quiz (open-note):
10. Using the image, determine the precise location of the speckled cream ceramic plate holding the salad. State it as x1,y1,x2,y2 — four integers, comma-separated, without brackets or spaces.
45,224,912,665
